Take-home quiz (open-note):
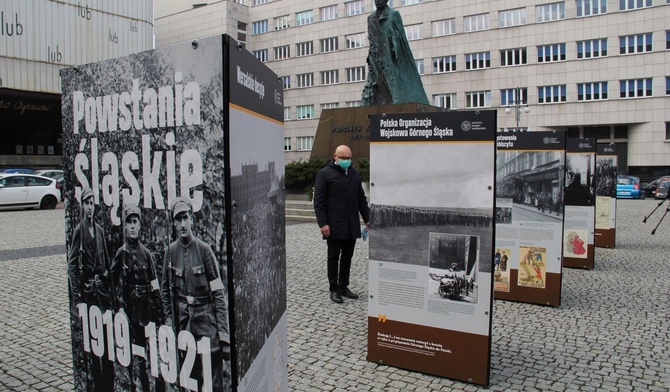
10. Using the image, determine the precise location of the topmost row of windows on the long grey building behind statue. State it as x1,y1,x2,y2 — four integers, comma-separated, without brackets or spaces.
253,0,652,34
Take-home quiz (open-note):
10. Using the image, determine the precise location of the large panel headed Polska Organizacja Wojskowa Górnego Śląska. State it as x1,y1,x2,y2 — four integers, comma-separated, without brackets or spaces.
368,111,496,385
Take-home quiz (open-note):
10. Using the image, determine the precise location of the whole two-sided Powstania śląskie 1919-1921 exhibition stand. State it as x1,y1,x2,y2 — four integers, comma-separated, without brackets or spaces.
61,35,288,392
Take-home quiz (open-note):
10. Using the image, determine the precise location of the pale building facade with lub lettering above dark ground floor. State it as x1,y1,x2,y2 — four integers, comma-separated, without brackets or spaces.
0,0,154,168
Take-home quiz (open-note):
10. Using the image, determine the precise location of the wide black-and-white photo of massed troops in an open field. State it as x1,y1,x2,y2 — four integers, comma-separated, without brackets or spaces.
370,143,494,272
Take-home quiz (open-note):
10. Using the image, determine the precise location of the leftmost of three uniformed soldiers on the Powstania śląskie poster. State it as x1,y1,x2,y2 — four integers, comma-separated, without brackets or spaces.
68,188,114,391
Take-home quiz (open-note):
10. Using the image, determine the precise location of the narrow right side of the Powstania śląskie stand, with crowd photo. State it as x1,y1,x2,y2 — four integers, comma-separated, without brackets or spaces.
227,37,288,392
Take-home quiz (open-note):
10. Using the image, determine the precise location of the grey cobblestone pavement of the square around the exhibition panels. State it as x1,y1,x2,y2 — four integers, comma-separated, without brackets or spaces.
0,200,670,391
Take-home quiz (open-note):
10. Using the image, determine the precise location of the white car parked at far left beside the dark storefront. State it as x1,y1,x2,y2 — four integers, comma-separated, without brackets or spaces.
0,174,61,210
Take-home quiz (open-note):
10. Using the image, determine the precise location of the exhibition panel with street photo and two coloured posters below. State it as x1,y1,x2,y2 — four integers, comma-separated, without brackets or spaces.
494,131,565,306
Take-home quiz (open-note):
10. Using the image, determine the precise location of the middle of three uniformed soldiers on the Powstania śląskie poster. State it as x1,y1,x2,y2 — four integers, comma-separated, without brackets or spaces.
111,205,164,392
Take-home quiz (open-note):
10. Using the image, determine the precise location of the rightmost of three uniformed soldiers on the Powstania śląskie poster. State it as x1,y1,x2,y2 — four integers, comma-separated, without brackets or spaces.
161,198,230,391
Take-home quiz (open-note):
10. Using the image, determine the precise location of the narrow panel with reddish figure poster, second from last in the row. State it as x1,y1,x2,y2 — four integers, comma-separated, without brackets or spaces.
563,139,597,269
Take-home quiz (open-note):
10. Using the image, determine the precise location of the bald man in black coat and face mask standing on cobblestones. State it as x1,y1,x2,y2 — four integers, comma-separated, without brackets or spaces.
314,145,370,303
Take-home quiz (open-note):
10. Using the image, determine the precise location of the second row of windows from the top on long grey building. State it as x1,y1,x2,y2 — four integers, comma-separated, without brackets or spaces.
252,30,670,66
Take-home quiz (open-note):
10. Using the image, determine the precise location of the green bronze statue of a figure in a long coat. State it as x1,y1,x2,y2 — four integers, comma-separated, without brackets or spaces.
362,0,429,106
